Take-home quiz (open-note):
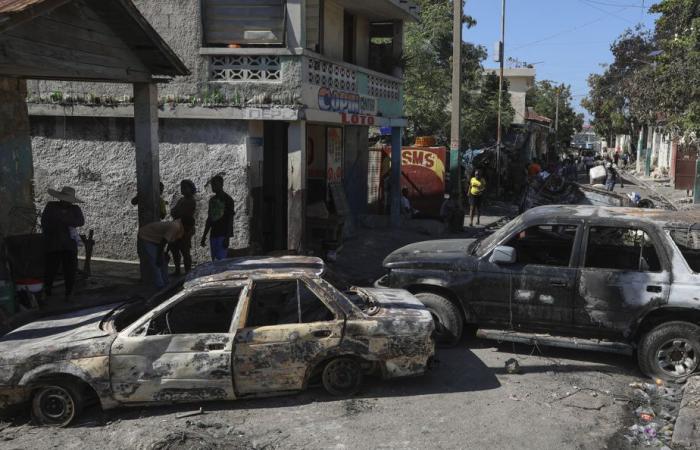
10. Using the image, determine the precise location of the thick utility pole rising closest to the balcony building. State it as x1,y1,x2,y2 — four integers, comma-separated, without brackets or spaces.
450,0,462,205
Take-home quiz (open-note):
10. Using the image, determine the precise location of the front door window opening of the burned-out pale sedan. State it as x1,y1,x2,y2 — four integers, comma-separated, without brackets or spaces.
147,287,242,336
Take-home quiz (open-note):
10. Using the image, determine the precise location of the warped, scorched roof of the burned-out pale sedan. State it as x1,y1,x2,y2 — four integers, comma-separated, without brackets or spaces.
185,256,326,287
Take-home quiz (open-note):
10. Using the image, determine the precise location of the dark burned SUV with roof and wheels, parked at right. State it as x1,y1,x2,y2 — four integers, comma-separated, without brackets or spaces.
376,206,700,380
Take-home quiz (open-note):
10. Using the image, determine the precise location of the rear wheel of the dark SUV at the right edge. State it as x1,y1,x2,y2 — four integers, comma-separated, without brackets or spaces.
637,321,700,381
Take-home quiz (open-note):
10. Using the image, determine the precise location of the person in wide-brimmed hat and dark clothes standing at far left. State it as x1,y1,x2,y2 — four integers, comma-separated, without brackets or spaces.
41,186,85,301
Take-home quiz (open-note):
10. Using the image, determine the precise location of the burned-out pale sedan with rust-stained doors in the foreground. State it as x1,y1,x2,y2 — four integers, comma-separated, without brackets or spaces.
0,257,434,426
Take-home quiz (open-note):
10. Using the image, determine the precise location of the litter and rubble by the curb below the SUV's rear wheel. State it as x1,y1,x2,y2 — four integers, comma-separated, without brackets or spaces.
625,380,682,448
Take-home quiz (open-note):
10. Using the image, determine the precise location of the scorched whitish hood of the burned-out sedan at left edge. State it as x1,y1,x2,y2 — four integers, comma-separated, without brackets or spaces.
0,304,119,365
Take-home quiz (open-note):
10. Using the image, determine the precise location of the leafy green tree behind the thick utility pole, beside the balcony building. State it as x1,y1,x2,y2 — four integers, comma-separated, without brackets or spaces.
404,0,512,148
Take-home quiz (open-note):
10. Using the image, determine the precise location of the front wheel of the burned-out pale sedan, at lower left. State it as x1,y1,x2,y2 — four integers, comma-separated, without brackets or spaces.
32,381,84,427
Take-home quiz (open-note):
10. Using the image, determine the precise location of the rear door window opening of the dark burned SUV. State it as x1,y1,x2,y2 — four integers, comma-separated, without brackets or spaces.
586,227,661,272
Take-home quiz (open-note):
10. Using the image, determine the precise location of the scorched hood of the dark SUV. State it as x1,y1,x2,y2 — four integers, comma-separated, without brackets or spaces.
384,239,476,269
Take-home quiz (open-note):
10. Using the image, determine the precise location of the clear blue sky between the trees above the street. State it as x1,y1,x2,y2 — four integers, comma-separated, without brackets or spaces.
462,0,657,118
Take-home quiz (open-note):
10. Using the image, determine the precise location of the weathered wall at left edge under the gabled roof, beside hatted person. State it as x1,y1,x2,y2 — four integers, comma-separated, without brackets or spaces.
0,78,36,236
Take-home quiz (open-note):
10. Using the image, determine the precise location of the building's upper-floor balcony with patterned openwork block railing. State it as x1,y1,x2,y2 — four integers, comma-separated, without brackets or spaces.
200,48,403,123
